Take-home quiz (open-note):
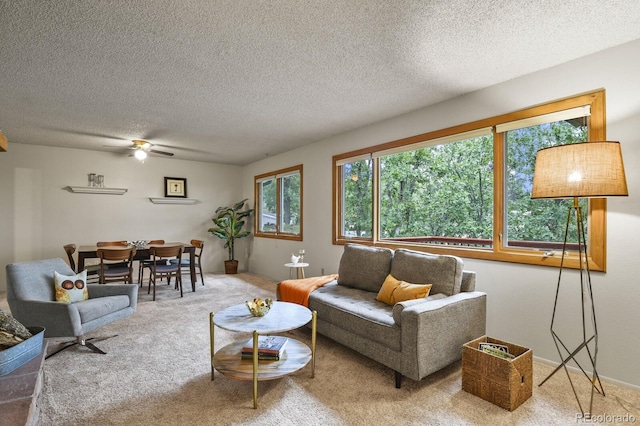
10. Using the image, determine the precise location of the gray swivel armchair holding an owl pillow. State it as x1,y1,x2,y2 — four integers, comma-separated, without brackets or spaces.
6,259,138,356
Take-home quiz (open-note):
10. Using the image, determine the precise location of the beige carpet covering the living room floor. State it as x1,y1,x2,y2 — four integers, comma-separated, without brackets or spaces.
0,274,640,426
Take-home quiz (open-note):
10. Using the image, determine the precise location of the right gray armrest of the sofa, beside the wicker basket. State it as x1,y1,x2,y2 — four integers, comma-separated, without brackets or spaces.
401,291,487,380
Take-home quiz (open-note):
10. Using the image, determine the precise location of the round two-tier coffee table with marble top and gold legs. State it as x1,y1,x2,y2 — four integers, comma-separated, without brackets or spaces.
209,302,317,408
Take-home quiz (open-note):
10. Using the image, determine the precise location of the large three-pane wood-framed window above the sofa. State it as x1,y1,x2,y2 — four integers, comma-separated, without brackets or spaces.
334,91,606,271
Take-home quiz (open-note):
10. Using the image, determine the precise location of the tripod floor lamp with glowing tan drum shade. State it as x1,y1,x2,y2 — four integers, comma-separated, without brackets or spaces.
531,141,628,415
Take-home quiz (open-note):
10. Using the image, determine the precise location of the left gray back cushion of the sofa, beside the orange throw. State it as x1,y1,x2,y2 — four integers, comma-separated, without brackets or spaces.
338,244,395,293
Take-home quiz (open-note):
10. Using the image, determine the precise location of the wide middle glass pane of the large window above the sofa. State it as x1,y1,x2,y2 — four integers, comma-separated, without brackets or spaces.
376,129,493,247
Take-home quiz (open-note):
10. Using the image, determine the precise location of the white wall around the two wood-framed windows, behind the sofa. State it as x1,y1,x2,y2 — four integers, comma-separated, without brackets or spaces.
243,41,640,386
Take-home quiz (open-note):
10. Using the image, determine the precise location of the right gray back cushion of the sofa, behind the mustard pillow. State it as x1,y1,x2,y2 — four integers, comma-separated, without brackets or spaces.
391,249,463,296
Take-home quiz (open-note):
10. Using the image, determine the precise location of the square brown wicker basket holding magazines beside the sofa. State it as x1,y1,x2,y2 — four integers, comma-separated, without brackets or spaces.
462,336,533,411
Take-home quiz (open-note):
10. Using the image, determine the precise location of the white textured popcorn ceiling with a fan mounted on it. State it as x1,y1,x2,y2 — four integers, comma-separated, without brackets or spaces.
0,0,640,165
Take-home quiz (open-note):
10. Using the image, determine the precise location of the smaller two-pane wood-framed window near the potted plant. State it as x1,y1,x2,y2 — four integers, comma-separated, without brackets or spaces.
255,164,302,241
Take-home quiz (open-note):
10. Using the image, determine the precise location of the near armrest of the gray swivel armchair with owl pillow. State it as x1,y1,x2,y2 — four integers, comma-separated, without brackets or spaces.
9,299,82,337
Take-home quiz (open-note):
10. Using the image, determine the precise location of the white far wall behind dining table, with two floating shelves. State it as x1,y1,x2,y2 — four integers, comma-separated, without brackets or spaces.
0,143,248,292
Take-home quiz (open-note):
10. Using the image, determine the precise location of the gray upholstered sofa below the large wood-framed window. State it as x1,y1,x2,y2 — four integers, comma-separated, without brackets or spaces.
309,244,486,388
